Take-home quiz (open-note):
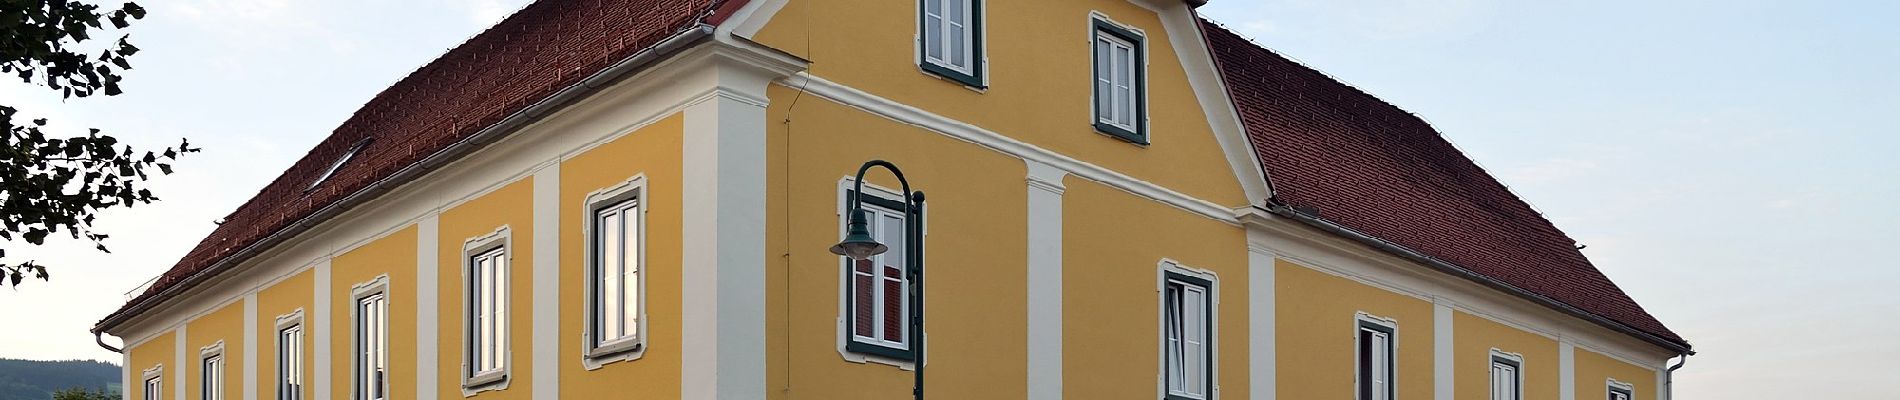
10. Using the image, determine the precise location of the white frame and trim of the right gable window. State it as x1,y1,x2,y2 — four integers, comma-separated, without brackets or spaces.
1089,13,1150,146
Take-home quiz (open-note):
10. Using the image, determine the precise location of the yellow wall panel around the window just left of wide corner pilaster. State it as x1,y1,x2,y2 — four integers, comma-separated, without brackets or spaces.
554,114,684,398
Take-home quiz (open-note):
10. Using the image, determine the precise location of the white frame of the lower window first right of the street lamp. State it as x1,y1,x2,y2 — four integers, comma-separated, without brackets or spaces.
1155,260,1220,400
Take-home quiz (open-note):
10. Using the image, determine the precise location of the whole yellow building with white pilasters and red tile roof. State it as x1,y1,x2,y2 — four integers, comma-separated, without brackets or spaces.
95,0,1691,400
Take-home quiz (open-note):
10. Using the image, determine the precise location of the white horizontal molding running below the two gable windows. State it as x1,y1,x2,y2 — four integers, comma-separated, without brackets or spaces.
781,72,1239,226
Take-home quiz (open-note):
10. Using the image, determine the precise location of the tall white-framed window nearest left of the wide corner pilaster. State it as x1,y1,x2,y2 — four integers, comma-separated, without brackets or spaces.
585,176,646,366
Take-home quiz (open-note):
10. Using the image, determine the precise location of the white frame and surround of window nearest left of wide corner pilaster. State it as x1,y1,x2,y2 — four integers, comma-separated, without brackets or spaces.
581,174,648,370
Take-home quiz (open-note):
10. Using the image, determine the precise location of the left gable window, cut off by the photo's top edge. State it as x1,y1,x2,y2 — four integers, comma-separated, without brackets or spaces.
918,0,982,87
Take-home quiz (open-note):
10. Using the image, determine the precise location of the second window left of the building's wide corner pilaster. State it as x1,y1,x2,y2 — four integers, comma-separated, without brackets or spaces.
462,244,507,385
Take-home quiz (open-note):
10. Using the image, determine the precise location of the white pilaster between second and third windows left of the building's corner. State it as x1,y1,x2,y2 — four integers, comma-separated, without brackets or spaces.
418,210,441,398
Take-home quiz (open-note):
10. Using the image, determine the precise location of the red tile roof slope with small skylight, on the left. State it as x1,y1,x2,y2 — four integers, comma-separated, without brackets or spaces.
95,0,745,330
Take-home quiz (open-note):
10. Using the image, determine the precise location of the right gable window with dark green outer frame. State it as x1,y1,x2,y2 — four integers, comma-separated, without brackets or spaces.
1094,19,1148,144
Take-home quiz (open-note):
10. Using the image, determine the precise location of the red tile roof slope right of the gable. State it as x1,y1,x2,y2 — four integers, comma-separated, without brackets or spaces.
1201,19,1687,347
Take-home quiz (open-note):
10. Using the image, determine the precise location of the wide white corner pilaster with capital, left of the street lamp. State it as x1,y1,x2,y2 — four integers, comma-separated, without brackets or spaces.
671,38,802,400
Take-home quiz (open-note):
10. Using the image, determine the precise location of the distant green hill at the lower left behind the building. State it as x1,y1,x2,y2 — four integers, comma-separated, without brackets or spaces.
0,358,120,400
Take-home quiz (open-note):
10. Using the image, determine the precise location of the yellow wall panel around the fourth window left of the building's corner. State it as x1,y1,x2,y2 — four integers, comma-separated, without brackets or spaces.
257,269,317,398
